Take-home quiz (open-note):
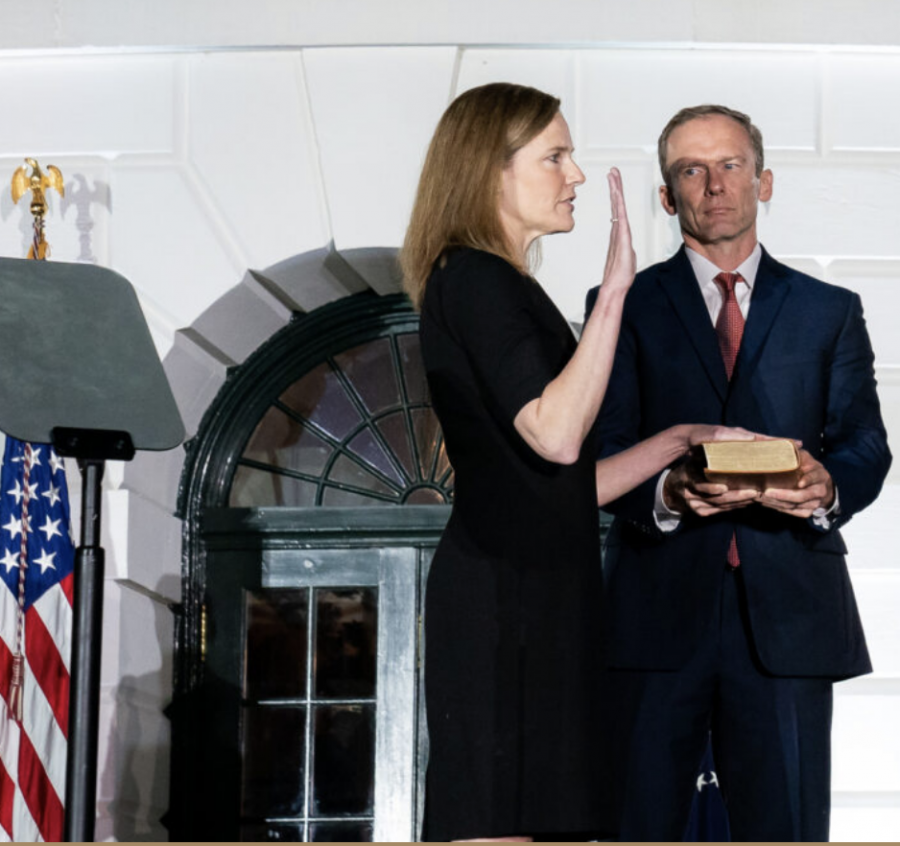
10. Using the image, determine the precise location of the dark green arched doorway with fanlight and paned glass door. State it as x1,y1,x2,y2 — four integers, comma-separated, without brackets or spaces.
167,294,453,840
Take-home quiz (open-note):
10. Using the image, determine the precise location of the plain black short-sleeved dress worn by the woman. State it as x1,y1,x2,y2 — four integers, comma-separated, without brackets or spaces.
420,249,606,840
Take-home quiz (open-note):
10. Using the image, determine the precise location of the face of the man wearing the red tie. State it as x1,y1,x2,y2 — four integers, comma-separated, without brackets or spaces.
659,115,772,252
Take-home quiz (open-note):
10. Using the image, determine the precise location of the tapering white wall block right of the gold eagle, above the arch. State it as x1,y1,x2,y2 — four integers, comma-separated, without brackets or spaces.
187,52,329,274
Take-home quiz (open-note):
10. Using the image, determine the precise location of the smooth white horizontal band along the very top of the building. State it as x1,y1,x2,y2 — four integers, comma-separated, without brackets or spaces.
8,0,900,49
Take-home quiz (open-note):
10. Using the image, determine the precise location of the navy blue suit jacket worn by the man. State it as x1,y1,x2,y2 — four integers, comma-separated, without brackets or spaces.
588,247,891,679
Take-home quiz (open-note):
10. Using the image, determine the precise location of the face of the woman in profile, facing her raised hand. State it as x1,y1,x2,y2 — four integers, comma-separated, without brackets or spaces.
499,113,584,255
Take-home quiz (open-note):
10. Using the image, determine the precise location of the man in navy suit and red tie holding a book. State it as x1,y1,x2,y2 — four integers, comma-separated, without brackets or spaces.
588,106,891,841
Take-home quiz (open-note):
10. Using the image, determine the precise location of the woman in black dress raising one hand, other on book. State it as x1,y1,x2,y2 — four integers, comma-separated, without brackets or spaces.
401,83,748,840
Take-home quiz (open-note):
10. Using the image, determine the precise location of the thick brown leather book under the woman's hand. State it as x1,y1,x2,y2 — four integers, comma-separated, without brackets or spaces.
703,438,800,491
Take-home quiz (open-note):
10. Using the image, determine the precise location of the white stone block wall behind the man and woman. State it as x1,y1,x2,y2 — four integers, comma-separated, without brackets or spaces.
0,26,900,839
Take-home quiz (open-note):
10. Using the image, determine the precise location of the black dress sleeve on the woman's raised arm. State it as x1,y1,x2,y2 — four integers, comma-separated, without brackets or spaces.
439,250,560,423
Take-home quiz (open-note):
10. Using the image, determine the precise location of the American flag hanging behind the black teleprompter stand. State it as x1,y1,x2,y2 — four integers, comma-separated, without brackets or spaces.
0,436,75,842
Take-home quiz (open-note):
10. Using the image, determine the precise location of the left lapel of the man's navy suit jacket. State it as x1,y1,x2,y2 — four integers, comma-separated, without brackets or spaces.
658,246,732,401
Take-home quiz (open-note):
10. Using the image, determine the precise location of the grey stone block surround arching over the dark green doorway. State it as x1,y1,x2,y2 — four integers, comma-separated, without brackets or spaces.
118,244,401,605
